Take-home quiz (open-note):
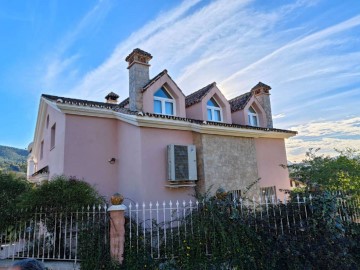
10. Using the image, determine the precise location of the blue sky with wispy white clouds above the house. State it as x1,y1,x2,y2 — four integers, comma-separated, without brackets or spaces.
0,0,360,160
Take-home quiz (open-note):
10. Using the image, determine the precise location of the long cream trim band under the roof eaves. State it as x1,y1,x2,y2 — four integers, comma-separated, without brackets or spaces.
56,103,295,138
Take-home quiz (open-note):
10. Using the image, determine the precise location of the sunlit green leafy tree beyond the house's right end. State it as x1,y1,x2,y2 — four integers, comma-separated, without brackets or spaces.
289,148,360,195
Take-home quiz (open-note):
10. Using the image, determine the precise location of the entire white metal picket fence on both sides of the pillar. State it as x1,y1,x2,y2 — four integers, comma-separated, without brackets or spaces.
0,195,360,262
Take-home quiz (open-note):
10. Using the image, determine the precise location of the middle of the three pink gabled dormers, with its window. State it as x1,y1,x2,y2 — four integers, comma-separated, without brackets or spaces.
185,82,231,123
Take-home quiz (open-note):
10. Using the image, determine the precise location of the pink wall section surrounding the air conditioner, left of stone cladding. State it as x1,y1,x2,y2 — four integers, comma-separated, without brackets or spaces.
118,122,193,202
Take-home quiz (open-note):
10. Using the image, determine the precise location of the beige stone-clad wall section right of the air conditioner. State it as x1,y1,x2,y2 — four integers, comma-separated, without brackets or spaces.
194,134,258,196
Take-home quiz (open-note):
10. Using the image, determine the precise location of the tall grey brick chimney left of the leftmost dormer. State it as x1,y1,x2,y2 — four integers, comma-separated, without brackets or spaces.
125,48,152,111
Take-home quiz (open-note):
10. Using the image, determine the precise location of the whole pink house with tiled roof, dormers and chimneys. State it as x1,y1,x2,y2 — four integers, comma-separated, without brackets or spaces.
28,49,296,204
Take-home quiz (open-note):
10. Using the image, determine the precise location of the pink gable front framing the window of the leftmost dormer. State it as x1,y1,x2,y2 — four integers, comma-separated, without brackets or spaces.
143,74,186,117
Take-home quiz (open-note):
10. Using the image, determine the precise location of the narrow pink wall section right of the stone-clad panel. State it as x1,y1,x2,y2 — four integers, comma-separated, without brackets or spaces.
255,138,290,200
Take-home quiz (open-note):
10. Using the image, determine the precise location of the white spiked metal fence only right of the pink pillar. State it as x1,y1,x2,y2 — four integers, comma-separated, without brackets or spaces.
126,195,360,259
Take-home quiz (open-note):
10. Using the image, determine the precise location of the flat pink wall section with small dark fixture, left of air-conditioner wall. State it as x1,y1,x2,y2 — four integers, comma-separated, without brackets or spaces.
64,115,119,198
